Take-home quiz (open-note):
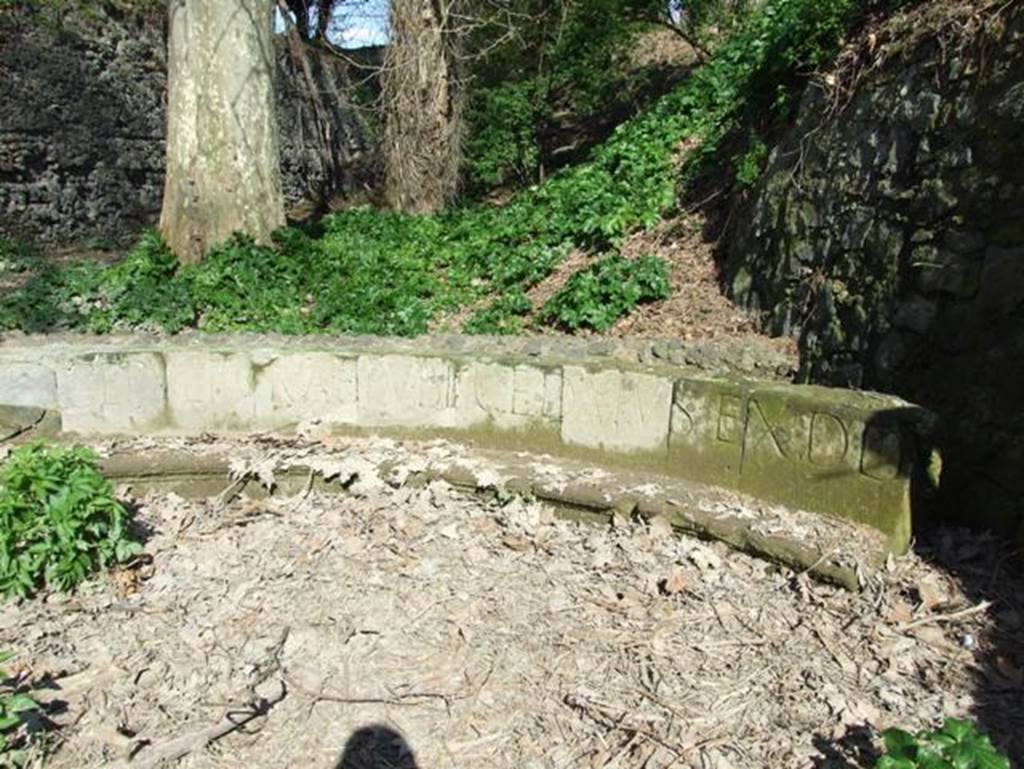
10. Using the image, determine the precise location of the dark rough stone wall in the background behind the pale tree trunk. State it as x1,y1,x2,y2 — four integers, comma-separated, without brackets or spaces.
0,9,370,245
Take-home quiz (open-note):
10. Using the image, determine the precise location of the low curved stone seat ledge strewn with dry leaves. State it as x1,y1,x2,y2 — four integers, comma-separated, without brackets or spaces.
102,439,890,591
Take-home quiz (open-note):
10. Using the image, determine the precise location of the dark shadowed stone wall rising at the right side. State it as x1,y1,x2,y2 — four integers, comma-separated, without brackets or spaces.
724,3,1024,537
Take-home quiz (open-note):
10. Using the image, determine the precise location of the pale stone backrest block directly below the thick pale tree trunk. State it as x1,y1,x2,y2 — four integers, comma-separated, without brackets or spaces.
167,350,256,430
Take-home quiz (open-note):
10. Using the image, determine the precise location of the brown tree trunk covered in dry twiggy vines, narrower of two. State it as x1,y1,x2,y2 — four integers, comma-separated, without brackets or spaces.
381,0,463,213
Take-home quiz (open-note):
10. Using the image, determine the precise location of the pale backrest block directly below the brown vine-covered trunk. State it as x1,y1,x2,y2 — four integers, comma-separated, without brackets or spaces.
356,354,455,427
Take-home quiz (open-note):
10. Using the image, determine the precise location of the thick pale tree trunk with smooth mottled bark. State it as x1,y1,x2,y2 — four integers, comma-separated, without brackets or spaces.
160,0,285,262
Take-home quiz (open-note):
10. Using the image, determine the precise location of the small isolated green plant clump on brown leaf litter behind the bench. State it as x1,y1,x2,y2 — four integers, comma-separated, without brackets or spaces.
541,254,670,331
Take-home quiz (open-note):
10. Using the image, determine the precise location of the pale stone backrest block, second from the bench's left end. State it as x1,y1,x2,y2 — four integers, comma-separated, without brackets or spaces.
57,352,167,433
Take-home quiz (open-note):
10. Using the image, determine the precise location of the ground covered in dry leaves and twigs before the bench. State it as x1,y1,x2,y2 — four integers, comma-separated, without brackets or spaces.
0,444,1024,769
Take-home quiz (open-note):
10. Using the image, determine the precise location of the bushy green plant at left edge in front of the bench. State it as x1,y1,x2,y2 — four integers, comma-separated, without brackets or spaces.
0,443,142,597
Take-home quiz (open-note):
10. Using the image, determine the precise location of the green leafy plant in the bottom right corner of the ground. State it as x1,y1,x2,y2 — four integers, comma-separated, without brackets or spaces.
874,718,1010,769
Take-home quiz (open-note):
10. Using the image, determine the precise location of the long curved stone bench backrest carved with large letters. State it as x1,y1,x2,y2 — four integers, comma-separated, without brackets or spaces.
0,335,930,552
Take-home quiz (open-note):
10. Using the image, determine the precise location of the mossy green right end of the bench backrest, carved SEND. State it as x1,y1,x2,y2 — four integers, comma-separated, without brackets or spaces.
669,380,925,551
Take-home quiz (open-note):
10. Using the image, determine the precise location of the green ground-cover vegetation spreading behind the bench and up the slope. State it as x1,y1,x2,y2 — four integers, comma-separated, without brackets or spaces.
0,0,901,335
